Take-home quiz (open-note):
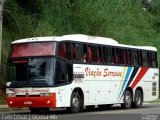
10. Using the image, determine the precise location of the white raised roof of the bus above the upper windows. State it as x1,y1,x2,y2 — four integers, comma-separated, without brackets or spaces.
12,34,157,51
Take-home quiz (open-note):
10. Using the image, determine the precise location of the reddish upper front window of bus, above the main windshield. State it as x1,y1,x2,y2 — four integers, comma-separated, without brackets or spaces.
12,42,56,57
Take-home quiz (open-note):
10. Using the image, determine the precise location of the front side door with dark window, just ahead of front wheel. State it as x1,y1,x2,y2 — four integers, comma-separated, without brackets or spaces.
55,59,73,107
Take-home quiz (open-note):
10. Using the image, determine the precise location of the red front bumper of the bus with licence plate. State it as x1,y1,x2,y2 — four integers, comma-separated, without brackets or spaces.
7,96,56,108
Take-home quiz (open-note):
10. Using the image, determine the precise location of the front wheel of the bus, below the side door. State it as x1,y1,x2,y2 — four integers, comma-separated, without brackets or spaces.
67,92,82,113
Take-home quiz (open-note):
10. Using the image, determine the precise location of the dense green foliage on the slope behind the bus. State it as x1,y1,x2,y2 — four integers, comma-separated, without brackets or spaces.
2,0,160,82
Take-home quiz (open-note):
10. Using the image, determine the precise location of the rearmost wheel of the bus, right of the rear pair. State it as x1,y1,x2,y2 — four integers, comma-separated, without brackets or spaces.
133,90,143,108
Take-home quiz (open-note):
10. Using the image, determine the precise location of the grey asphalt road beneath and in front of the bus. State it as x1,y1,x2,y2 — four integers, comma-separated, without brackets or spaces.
0,104,160,120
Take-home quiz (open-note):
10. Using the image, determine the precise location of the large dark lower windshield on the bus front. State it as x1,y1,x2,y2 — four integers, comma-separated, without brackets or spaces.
9,58,54,87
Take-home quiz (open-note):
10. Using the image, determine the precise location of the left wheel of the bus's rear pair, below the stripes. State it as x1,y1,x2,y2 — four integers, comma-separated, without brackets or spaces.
122,90,133,109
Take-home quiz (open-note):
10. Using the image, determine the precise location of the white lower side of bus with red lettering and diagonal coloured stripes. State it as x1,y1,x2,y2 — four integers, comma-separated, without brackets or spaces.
65,64,159,106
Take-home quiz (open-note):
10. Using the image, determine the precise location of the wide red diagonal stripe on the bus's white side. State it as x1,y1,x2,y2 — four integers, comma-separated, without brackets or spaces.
131,68,149,89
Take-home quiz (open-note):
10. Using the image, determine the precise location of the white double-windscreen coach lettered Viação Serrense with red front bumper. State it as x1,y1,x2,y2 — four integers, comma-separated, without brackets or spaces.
6,34,159,113
